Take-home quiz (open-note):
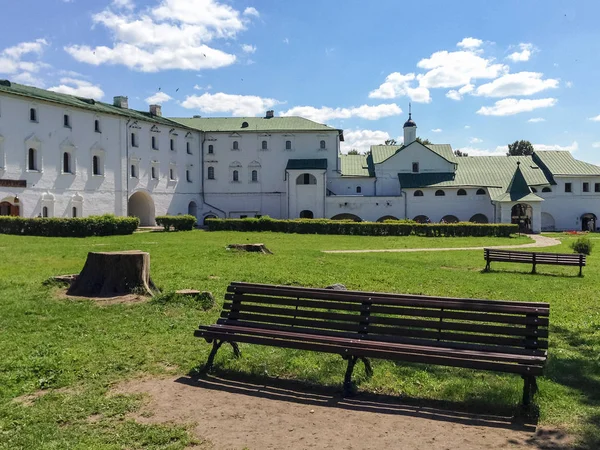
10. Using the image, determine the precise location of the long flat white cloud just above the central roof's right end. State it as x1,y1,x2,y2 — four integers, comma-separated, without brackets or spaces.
281,103,402,123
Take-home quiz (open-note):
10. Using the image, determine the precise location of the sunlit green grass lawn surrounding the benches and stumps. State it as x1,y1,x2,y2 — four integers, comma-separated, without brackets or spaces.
0,231,600,449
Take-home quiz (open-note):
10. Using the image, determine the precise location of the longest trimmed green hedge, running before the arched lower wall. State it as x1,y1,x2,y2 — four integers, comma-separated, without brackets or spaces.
206,216,519,237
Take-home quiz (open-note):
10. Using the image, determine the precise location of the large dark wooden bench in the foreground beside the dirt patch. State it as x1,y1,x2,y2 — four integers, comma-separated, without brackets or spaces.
195,282,550,405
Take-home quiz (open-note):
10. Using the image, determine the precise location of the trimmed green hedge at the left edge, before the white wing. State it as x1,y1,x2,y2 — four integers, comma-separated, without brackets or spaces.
0,214,140,237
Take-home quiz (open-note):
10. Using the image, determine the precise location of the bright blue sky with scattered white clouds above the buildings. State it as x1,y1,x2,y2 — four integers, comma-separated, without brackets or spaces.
0,0,600,163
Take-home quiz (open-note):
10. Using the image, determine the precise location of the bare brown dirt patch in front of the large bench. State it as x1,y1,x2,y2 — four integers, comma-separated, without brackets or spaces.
114,377,571,450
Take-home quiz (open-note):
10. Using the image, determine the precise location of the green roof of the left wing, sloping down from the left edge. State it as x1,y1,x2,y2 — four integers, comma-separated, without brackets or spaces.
0,81,186,127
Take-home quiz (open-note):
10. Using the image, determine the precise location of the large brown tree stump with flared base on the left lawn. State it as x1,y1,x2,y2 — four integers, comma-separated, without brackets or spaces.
67,250,156,297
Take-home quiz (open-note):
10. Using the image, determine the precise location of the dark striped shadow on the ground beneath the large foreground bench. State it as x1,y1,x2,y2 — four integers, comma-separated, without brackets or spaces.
175,368,537,433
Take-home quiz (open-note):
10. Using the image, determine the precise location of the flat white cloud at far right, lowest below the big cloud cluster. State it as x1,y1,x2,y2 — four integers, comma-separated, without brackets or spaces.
474,72,558,97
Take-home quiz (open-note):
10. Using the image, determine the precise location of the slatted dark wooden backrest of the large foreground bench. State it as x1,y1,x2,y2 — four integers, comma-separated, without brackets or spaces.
218,282,550,355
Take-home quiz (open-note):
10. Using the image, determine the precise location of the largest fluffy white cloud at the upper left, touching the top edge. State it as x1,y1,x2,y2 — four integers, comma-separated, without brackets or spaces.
65,0,253,72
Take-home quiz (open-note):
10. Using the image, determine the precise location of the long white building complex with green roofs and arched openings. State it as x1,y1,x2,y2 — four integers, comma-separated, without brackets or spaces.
0,80,600,232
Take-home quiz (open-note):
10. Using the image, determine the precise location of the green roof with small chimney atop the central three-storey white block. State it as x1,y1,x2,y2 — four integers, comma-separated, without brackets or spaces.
172,117,341,133
